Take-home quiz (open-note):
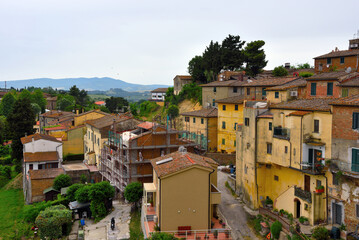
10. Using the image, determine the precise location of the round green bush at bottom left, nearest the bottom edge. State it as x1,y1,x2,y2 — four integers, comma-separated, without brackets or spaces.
35,205,72,239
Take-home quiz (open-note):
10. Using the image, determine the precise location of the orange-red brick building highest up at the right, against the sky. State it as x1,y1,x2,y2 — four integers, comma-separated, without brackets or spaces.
314,39,359,73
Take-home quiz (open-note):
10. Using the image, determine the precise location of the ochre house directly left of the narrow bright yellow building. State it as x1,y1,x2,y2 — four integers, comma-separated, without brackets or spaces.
181,108,218,152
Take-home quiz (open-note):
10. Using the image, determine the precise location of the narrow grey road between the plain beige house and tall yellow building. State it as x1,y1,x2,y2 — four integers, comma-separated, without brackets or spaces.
217,171,258,240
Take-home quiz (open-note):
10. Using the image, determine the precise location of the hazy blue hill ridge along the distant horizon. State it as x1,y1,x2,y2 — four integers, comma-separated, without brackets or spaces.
0,77,169,92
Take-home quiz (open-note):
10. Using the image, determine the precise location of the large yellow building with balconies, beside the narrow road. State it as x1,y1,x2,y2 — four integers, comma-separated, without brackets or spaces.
236,99,332,224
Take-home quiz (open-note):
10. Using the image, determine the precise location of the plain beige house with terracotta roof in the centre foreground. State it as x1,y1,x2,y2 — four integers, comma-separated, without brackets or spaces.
143,150,221,231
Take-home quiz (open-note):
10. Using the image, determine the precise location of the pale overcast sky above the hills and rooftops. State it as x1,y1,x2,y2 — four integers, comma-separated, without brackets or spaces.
0,0,359,85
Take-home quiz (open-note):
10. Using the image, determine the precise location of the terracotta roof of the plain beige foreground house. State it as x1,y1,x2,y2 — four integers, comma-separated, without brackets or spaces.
150,152,218,178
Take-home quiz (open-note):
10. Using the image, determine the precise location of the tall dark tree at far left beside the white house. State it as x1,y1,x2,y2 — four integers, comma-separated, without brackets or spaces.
7,98,35,164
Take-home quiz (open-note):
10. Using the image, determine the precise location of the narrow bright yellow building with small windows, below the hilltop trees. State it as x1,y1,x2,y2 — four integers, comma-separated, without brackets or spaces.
216,96,244,153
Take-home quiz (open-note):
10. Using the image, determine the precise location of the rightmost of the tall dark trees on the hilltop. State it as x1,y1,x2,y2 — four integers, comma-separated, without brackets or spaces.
244,40,268,76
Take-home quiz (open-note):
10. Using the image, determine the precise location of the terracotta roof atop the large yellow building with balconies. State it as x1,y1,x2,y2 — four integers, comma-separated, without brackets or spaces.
269,98,334,112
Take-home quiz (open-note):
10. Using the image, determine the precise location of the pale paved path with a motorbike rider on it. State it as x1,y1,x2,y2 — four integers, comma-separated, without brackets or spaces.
84,201,131,240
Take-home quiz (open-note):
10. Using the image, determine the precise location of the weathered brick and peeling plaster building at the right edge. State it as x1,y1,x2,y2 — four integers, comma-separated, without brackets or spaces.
328,95,359,232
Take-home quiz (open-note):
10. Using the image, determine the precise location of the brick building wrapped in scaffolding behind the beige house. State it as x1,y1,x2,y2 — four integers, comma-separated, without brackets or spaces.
100,122,197,194
